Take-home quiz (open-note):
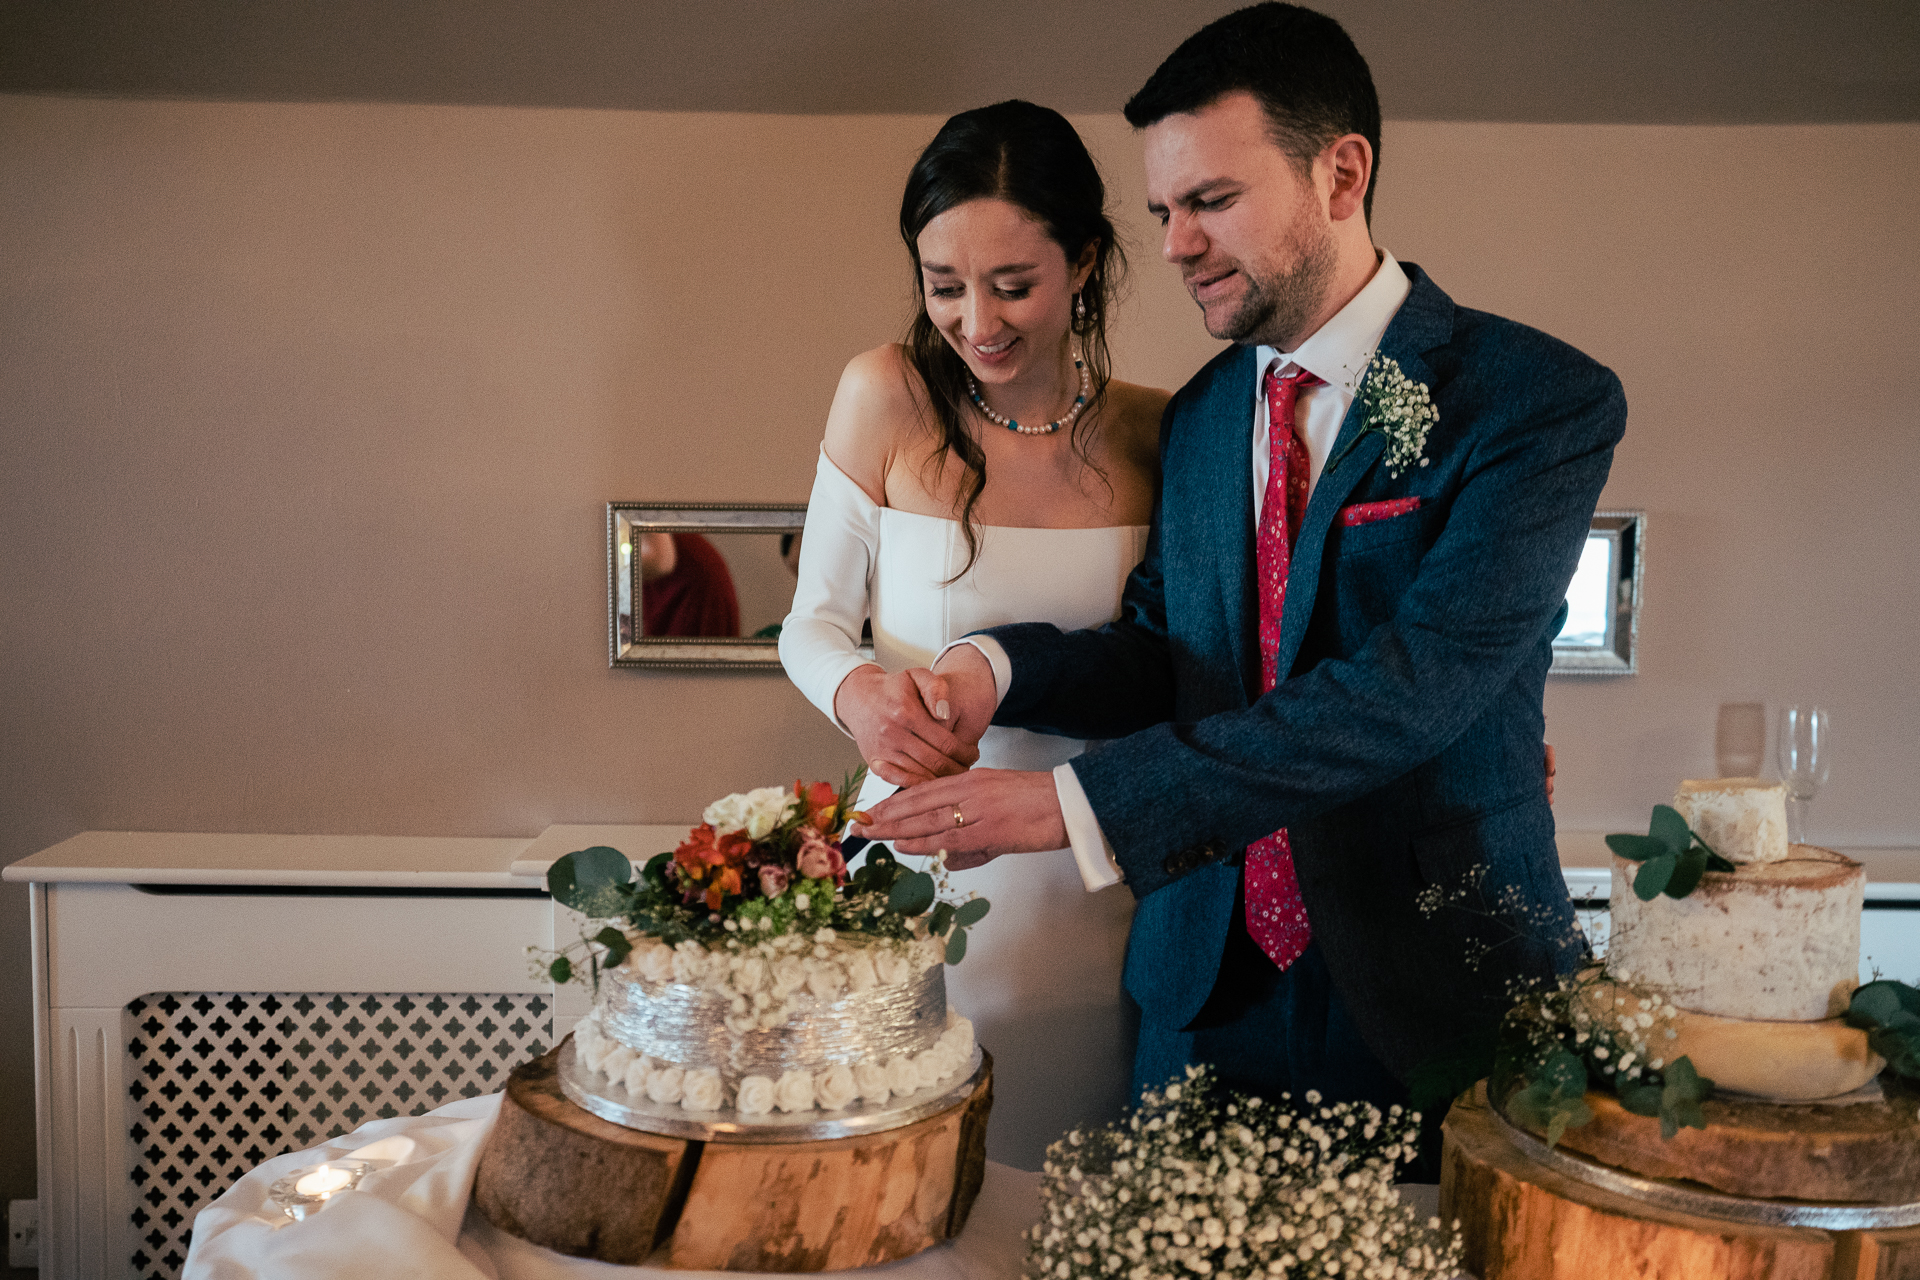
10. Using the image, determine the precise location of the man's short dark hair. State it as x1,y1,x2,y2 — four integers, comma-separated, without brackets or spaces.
1127,4,1380,225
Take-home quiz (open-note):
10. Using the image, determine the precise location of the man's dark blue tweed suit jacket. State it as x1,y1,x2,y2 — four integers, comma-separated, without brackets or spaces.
993,265,1626,1082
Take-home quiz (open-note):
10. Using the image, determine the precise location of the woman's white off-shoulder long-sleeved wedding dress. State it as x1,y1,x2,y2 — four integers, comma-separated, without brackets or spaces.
780,451,1146,1169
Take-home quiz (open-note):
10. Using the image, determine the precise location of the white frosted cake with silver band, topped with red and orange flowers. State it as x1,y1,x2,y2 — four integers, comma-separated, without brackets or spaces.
541,773,987,1119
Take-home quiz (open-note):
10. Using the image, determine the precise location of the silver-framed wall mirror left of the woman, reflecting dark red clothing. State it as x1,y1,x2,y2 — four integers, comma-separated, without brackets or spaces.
607,503,806,668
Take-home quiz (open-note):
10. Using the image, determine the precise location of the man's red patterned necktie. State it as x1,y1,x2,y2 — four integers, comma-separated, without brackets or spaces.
1246,365,1323,969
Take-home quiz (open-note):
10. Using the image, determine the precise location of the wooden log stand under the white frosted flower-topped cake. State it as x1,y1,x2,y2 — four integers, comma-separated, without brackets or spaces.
474,1046,993,1270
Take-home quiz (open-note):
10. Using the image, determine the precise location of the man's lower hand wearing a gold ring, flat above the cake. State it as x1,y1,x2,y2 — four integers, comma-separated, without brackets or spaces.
858,770,1068,871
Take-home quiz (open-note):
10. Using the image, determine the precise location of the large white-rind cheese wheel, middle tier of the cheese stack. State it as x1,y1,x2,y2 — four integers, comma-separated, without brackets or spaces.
1607,852,1866,1023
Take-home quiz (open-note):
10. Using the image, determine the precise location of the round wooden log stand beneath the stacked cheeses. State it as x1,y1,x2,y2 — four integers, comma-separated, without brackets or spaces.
1440,1077,1920,1280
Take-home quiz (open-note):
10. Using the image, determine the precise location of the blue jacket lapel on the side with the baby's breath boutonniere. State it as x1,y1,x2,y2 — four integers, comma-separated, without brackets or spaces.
1274,272,1453,687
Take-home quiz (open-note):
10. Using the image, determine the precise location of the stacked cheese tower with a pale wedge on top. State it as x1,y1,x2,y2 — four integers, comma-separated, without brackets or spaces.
1607,777,1884,1102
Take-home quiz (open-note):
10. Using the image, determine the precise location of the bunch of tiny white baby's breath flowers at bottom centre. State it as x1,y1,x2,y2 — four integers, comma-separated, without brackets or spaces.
1025,1067,1461,1280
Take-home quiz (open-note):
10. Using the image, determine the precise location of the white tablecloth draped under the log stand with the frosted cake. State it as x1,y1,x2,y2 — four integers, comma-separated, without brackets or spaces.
182,1094,1041,1280
